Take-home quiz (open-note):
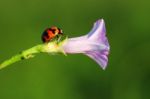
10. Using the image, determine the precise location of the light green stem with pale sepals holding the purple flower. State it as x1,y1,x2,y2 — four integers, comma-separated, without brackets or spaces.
0,37,67,69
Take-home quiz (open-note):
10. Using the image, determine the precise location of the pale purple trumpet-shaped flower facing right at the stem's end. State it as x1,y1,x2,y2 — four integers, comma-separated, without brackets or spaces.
62,19,110,69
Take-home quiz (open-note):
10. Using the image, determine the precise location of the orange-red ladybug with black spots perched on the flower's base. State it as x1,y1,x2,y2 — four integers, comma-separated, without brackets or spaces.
42,26,63,43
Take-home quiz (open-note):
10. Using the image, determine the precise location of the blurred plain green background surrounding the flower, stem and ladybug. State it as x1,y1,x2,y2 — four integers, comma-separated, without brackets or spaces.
0,0,150,99
